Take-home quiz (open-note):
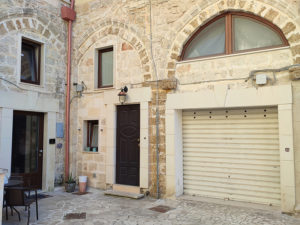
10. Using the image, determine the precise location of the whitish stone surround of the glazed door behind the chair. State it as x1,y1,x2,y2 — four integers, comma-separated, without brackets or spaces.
0,91,59,191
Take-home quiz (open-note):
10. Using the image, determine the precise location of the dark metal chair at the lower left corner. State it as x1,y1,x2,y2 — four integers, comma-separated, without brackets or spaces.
5,187,38,225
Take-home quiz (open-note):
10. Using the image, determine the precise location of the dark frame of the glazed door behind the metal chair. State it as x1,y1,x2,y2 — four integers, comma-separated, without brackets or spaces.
11,110,45,189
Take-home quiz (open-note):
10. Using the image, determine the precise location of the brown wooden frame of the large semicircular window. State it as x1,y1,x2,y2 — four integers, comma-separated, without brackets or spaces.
180,12,289,61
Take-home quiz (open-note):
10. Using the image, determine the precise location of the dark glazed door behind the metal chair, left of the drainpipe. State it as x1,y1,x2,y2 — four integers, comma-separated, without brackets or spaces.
11,111,44,188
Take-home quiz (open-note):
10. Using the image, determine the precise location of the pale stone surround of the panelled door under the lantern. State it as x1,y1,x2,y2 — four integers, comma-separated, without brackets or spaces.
100,87,152,189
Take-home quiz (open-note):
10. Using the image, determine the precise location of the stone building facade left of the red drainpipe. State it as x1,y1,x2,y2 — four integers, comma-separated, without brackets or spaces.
0,0,68,190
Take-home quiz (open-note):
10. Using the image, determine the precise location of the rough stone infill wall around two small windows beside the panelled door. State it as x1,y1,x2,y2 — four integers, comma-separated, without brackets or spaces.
71,31,144,188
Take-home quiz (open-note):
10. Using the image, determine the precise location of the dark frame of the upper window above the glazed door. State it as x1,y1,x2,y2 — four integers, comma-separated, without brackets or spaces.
20,38,42,85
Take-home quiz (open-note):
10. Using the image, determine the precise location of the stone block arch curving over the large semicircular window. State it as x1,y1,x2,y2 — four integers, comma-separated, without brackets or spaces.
166,0,300,78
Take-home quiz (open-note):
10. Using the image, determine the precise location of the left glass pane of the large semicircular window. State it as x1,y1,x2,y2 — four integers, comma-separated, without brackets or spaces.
184,17,225,59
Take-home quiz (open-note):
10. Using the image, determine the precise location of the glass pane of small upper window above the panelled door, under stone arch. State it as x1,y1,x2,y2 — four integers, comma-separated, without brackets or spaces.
101,51,113,86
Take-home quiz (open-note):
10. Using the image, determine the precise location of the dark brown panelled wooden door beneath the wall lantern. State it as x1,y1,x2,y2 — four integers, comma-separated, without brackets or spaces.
117,105,140,186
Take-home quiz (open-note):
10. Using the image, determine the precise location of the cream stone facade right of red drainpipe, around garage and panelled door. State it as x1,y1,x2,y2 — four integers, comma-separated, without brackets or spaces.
71,0,300,212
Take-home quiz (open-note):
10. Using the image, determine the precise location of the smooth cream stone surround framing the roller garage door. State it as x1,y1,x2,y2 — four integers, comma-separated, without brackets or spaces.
166,85,296,212
